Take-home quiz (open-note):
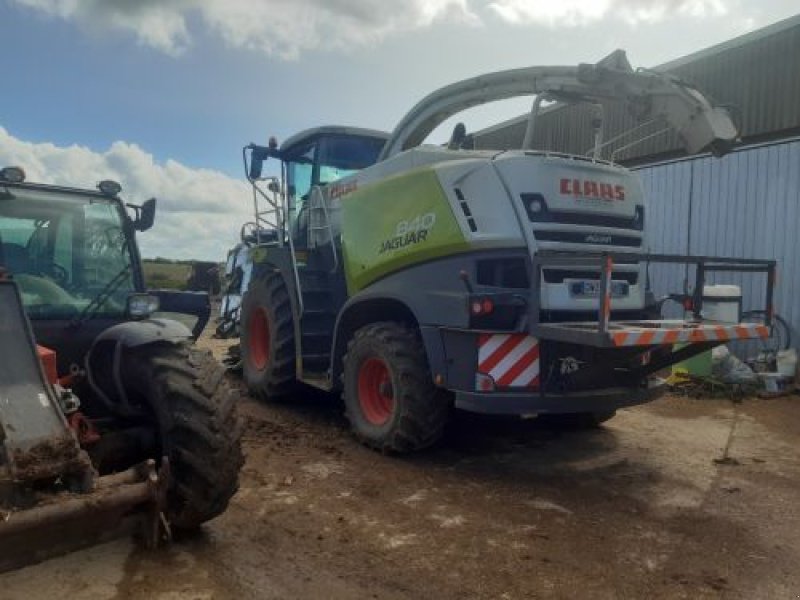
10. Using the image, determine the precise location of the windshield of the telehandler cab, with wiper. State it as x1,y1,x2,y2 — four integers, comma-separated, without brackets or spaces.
0,188,135,319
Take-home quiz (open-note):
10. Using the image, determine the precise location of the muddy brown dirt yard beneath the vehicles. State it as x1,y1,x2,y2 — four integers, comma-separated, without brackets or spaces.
0,336,800,600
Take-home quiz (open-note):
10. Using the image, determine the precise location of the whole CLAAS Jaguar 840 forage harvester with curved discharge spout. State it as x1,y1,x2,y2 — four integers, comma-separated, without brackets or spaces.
236,51,774,452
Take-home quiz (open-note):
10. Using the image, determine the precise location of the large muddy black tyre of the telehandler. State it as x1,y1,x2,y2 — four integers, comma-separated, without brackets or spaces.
125,344,244,529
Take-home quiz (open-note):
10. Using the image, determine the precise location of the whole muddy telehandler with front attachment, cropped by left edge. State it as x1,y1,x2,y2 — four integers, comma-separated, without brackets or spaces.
0,168,242,571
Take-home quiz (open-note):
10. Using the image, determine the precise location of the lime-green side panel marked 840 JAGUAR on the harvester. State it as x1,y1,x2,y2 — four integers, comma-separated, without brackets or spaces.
341,169,469,295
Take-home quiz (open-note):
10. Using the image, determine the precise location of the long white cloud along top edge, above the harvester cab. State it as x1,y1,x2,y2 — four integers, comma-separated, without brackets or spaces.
13,0,478,58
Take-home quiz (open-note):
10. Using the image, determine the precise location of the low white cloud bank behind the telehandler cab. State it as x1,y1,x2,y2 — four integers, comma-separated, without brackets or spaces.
0,127,252,260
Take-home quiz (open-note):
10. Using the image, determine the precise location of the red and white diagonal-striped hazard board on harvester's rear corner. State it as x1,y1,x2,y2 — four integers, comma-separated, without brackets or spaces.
478,333,539,388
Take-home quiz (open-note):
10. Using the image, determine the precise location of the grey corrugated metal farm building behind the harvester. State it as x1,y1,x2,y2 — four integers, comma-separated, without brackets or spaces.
475,15,800,341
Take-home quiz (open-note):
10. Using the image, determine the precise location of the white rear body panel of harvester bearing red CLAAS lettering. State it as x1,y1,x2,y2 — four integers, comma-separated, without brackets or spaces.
428,151,645,311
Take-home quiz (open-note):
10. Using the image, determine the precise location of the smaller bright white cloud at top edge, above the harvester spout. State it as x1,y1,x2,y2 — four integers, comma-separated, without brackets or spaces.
488,0,728,27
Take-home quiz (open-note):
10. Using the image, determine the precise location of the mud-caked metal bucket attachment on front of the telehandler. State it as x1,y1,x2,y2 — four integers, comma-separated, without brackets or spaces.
0,280,169,572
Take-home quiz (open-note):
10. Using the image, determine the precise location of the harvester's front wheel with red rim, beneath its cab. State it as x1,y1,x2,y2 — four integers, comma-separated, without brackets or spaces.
240,273,296,400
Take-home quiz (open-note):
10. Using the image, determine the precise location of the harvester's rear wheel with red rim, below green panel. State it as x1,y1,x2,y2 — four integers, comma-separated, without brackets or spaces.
342,322,450,452
